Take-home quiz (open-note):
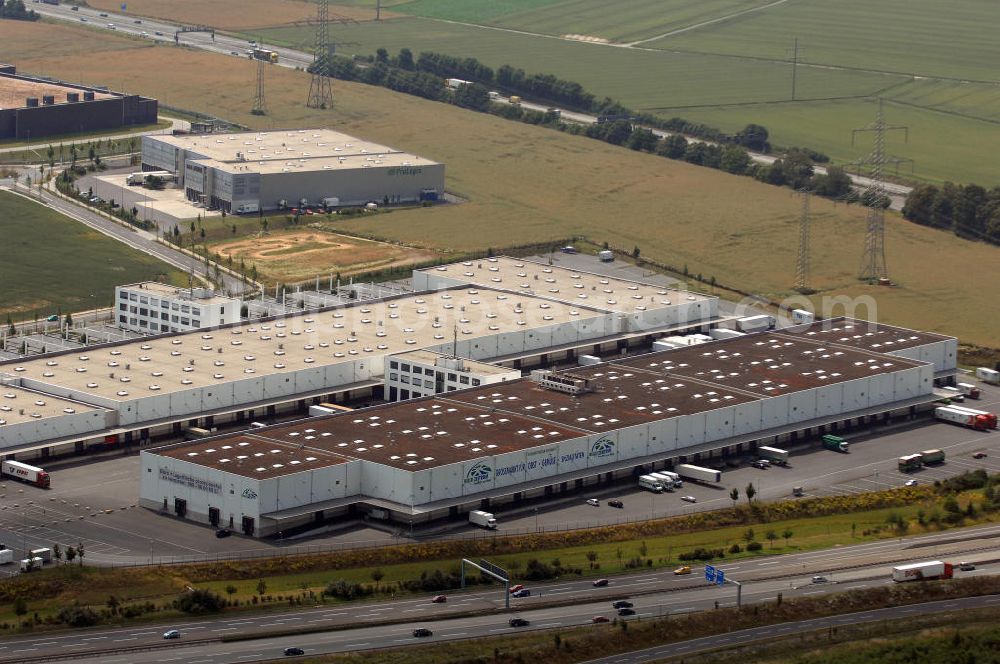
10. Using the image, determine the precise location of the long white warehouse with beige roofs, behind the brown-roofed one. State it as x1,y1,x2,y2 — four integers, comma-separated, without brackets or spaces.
0,258,719,459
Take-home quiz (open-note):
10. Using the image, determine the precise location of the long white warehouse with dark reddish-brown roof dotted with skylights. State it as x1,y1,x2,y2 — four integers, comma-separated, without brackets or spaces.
140,319,956,536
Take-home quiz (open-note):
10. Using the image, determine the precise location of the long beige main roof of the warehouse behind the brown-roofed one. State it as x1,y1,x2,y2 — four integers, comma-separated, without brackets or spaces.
0,287,607,401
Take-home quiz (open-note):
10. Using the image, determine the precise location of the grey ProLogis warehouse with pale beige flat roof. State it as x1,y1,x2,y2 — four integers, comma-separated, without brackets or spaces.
142,129,444,212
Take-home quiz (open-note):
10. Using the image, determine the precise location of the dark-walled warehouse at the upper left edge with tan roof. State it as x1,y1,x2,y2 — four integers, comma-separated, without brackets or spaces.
0,65,157,140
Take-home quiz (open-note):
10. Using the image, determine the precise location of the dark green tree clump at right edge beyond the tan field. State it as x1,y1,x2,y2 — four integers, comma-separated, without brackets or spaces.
903,182,1000,244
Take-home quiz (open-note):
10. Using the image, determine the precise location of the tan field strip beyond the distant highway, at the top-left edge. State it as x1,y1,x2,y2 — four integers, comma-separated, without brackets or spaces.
89,0,385,30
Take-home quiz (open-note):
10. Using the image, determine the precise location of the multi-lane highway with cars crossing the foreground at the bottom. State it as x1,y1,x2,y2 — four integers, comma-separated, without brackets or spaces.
0,525,1000,664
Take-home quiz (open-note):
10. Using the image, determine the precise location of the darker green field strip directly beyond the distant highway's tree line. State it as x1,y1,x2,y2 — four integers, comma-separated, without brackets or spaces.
260,18,901,109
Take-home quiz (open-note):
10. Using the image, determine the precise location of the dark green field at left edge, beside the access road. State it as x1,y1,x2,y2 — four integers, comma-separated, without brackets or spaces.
0,192,186,320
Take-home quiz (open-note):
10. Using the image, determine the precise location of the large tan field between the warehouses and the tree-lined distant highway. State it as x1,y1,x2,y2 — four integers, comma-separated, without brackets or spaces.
0,23,1000,347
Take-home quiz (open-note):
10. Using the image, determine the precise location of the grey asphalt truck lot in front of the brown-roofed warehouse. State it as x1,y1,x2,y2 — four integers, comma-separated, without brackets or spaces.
0,388,1000,573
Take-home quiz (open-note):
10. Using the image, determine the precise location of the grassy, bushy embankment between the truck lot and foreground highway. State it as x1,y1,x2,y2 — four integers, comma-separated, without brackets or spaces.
0,471,1000,634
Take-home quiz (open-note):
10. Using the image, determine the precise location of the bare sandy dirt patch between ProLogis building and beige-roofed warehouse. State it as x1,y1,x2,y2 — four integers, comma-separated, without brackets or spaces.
211,228,435,282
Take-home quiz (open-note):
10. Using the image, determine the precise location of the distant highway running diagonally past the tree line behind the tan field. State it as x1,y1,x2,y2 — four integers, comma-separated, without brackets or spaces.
34,5,912,210
